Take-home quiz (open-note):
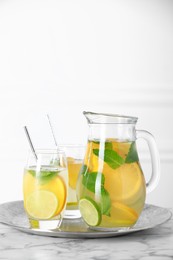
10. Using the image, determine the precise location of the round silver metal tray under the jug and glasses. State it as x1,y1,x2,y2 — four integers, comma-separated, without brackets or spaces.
0,201,172,238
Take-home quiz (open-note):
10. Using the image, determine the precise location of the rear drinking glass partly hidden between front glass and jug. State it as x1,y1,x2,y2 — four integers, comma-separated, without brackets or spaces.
59,144,85,219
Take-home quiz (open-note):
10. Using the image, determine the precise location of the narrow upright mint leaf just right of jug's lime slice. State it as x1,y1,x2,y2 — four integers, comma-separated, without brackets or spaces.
101,188,111,216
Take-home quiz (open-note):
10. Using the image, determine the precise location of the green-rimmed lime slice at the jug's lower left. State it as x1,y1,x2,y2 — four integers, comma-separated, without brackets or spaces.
79,198,101,227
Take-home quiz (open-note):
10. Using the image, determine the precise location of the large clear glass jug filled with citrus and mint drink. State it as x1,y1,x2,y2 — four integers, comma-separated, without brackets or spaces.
77,112,160,230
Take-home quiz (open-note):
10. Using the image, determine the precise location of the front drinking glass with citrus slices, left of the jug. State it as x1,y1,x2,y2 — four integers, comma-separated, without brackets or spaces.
23,150,68,229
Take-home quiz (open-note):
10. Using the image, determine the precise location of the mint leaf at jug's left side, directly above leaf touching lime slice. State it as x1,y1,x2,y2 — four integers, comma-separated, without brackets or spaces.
82,172,105,193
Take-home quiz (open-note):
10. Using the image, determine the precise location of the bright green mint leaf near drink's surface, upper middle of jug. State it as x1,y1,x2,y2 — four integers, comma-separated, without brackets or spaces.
93,149,124,169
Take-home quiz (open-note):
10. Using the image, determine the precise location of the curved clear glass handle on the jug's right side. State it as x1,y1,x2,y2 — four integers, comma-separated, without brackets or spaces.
136,130,160,193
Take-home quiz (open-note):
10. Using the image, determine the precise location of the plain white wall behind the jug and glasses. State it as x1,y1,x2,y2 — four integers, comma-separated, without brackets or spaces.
0,0,173,207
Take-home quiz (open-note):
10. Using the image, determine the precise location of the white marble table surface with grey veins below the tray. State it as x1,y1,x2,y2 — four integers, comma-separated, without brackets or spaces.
0,211,173,260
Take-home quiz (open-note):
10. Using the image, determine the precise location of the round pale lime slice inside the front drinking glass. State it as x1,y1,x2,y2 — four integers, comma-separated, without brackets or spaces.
25,190,58,220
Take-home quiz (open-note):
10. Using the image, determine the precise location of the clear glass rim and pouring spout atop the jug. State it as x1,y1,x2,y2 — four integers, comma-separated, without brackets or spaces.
83,111,138,124
